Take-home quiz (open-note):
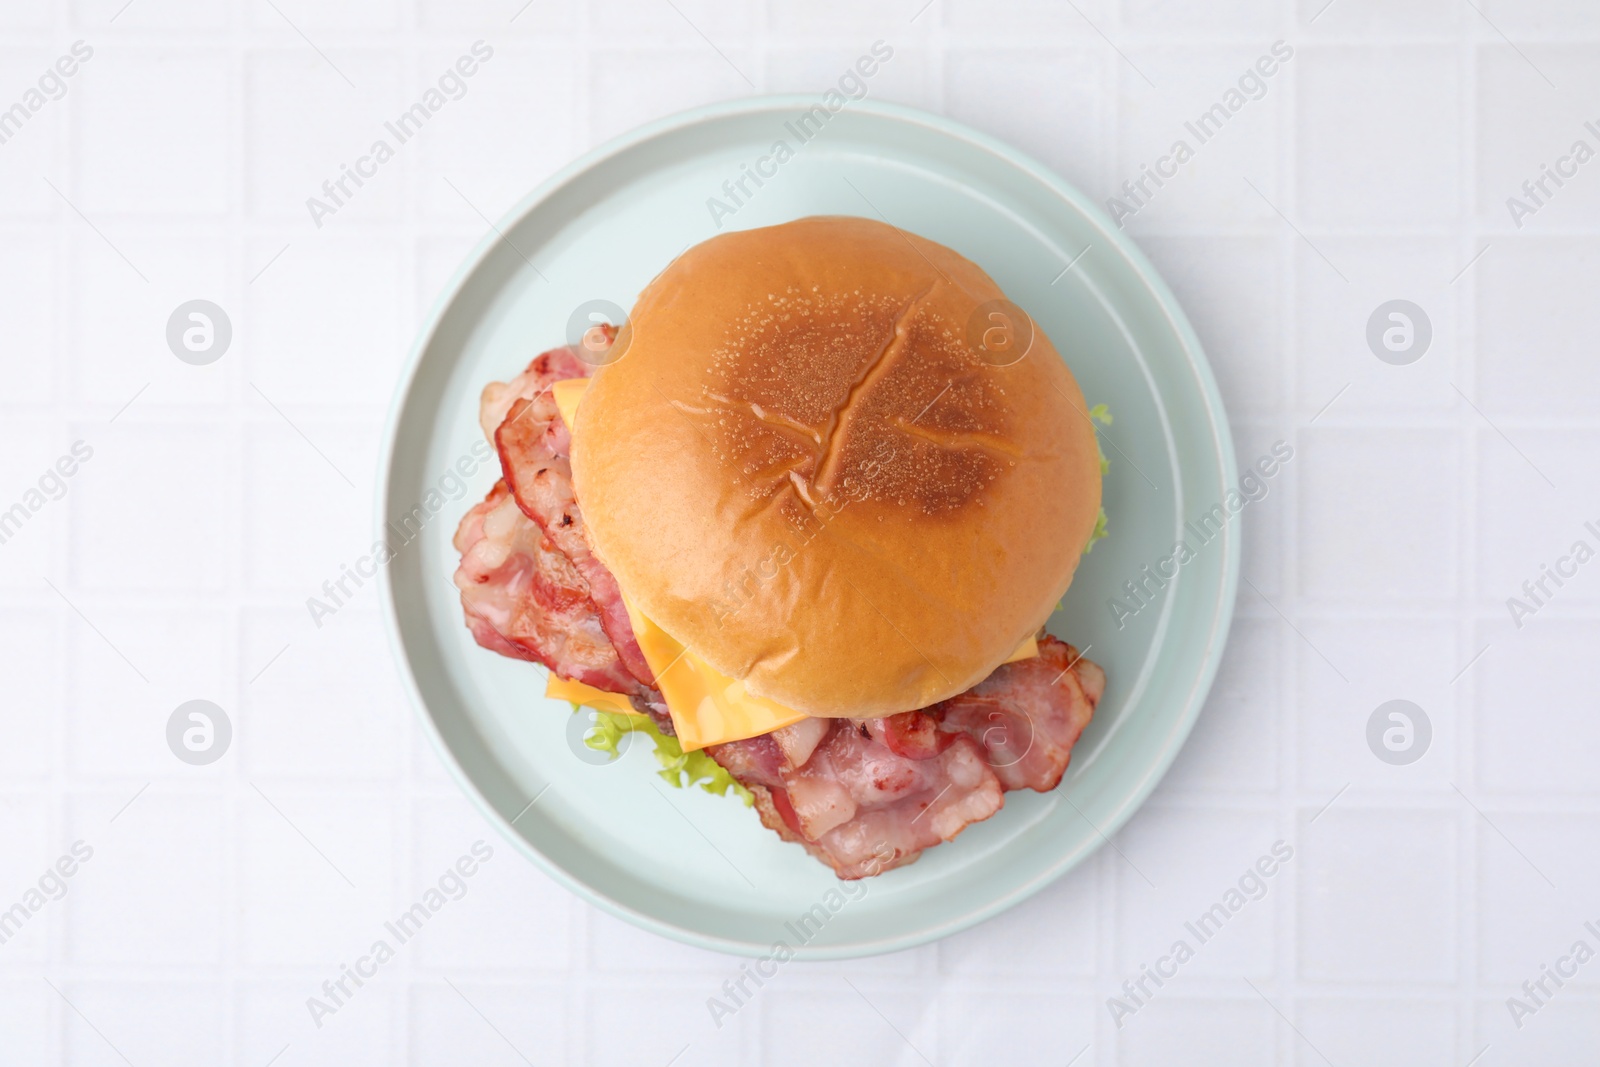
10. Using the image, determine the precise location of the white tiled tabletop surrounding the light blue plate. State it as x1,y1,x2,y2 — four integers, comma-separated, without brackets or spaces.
0,0,1600,1067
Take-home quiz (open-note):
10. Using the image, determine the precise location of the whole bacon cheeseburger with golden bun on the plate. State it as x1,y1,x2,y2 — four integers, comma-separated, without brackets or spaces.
454,216,1106,878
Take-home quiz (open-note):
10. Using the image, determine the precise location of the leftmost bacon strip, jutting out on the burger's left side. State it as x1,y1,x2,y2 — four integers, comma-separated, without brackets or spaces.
454,482,640,693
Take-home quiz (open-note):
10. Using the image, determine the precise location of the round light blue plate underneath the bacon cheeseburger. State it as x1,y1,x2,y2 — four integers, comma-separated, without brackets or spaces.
378,96,1238,958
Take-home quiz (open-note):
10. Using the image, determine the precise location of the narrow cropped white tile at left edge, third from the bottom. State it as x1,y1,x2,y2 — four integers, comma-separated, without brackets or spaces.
0,608,66,782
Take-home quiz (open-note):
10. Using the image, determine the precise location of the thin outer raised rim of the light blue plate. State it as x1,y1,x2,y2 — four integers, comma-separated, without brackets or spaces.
373,93,1245,960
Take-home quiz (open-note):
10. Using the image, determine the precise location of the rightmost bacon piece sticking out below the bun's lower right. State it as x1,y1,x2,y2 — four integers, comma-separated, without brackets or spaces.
928,633,1106,792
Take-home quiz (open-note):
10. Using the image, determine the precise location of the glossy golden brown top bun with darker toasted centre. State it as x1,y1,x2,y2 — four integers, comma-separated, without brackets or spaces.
573,216,1101,718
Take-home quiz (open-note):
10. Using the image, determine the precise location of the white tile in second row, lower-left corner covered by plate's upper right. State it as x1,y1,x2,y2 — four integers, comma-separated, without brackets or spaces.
944,50,1110,201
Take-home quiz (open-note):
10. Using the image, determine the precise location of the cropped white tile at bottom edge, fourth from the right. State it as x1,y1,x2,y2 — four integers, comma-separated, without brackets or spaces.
939,989,1104,1064
